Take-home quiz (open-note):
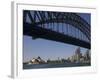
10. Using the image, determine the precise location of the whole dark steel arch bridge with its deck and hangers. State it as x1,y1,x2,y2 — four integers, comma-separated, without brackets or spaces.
23,10,91,49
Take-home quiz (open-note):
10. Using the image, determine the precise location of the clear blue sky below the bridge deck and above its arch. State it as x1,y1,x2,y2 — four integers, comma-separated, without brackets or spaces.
23,13,91,62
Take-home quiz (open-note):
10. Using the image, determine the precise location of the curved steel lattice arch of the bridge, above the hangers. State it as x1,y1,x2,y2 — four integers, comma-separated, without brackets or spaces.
23,10,91,49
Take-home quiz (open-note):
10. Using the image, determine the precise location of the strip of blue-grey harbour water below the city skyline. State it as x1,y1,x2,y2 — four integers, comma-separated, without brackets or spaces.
23,63,90,69
